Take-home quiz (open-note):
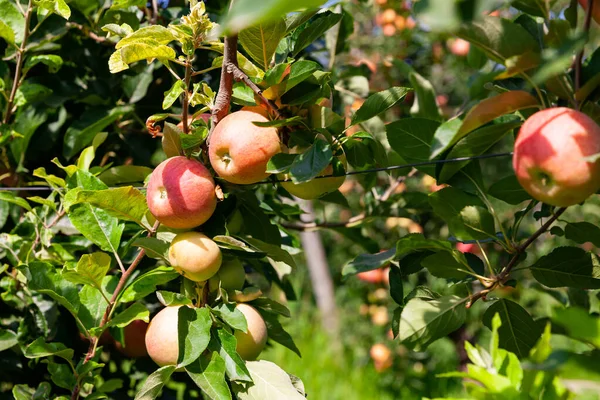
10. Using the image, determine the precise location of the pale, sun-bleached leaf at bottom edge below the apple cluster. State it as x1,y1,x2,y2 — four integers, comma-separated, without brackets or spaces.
234,360,305,400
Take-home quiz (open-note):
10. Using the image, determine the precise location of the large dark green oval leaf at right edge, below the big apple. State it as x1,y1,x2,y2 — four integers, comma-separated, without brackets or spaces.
530,247,600,289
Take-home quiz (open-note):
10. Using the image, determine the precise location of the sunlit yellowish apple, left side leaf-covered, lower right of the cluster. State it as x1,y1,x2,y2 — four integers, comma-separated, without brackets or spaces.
234,303,267,361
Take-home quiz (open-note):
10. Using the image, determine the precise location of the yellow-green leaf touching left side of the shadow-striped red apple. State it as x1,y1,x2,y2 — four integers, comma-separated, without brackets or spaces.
65,186,148,227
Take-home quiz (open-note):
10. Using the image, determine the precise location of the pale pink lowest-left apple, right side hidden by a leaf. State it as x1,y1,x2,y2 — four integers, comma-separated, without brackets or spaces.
146,306,181,367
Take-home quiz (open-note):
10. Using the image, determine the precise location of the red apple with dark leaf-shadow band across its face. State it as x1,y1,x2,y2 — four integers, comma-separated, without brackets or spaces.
146,156,217,229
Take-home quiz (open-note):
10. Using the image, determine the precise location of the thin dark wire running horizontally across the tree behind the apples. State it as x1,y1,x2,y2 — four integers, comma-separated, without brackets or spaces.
0,152,513,192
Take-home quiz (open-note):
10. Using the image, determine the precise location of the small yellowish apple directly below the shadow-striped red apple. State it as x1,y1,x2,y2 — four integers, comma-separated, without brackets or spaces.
169,232,222,282
